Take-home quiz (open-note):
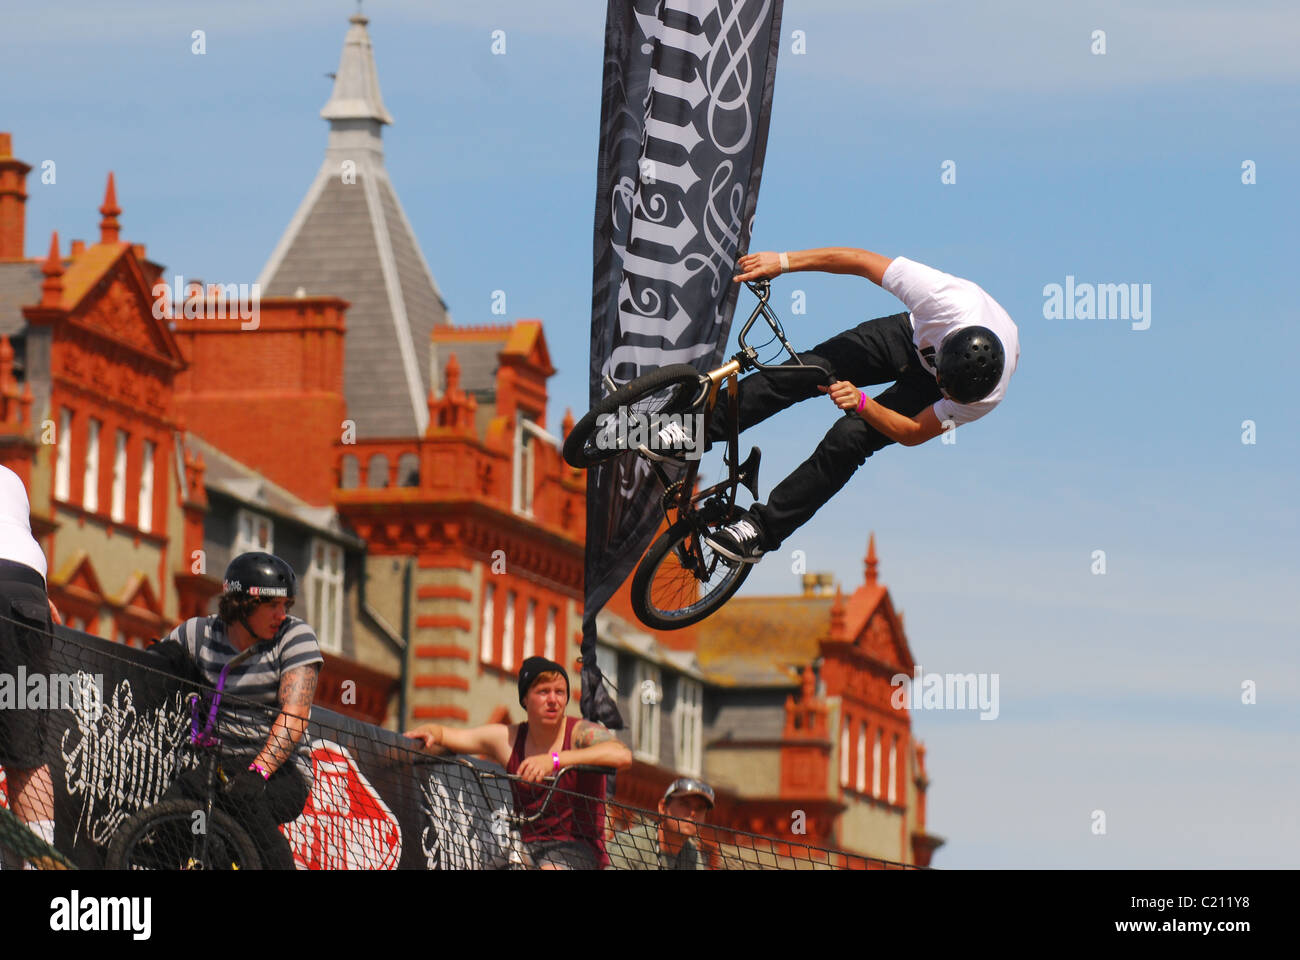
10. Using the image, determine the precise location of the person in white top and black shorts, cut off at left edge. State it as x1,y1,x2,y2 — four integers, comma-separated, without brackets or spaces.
0,466,62,866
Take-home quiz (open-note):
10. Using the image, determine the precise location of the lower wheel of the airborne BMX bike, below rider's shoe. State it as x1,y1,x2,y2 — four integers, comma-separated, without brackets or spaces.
632,518,754,630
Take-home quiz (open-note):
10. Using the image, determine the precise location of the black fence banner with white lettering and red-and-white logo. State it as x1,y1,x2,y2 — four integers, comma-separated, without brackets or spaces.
13,627,511,870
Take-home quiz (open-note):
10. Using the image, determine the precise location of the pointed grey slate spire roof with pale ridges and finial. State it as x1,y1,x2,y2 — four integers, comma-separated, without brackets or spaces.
257,14,447,437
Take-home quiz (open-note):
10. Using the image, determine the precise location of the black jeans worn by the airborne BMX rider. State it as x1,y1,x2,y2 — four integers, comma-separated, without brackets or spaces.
709,313,943,541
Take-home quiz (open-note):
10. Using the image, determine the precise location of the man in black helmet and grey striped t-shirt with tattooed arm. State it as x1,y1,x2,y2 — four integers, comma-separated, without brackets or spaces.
153,553,324,869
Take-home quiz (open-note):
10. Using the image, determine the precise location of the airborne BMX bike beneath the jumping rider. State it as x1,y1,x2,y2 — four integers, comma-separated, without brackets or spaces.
563,280,852,630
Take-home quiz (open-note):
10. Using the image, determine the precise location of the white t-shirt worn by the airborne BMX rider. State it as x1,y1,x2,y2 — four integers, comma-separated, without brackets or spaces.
880,256,1021,427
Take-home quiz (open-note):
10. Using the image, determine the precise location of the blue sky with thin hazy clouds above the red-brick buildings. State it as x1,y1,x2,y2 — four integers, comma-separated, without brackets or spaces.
0,0,1300,868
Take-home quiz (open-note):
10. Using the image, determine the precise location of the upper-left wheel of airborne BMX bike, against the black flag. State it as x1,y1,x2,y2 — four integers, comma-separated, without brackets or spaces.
564,363,707,467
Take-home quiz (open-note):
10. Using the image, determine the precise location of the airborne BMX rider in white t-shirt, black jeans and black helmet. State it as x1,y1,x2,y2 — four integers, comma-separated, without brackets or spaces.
707,247,1021,563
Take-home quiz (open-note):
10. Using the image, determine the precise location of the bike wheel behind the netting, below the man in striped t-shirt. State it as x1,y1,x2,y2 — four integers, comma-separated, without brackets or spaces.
104,796,263,870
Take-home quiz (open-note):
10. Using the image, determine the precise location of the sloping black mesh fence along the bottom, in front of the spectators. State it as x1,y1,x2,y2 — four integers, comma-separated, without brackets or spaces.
0,623,906,870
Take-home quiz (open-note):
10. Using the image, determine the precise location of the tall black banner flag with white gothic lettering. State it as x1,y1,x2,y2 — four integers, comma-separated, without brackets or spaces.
582,0,781,728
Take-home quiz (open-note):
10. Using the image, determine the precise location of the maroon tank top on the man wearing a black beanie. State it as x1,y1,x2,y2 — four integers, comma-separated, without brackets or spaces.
506,717,610,870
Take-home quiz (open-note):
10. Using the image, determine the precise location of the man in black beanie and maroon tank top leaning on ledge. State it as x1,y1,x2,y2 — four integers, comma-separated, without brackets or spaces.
406,657,632,870
